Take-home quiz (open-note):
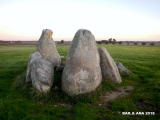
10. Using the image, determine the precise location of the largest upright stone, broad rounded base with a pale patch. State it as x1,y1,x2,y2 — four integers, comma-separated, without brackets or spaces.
62,29,102,96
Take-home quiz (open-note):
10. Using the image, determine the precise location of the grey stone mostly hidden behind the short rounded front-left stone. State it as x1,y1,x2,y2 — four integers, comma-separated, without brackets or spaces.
26,52,42,82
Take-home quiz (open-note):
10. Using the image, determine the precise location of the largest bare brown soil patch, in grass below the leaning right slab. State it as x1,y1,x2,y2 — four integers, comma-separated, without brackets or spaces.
94,86,134,106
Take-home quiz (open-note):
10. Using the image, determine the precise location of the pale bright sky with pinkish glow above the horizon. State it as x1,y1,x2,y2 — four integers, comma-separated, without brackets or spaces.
0,0,160,41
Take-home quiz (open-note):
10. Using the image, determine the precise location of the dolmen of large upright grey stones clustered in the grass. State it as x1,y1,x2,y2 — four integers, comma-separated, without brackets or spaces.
26,29,122,96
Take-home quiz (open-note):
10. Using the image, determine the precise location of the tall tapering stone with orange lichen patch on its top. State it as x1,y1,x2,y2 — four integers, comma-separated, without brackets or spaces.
37,29,61,67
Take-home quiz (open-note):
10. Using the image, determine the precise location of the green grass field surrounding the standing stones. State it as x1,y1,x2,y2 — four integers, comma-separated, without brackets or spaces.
0,44,160,120
